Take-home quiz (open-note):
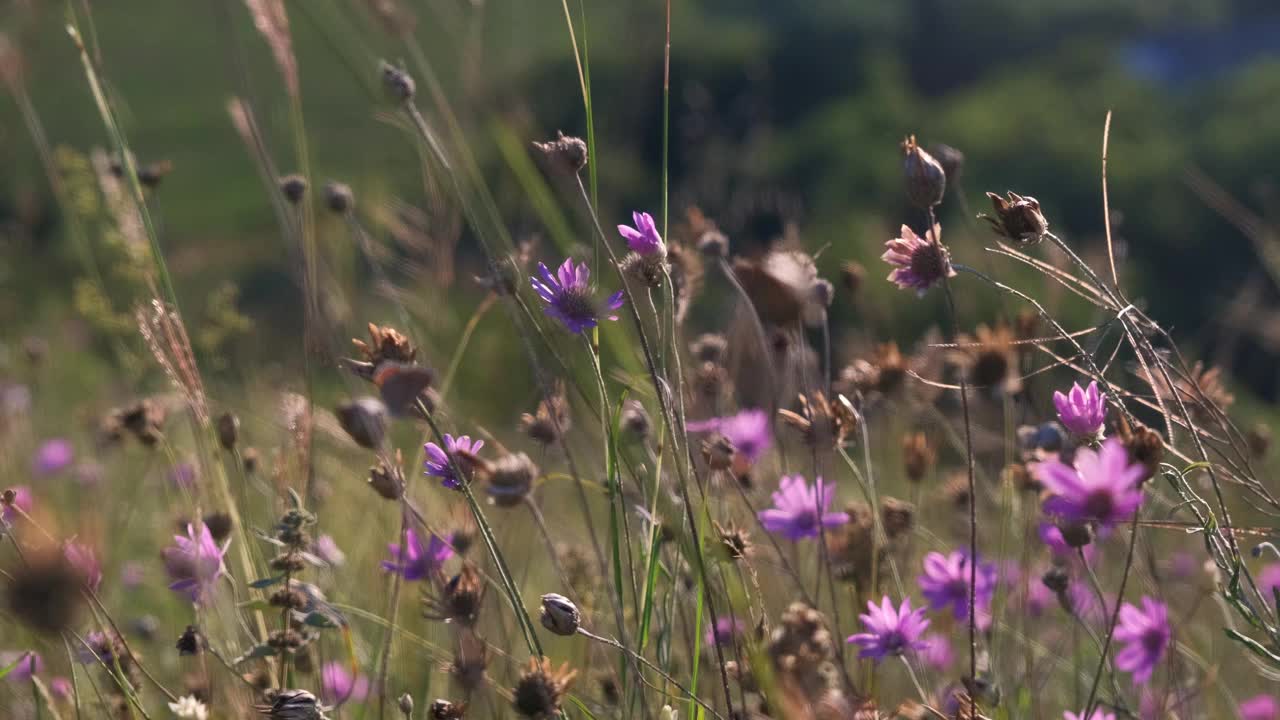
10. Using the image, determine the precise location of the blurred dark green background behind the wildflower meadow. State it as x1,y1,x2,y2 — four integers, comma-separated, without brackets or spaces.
0,0,1280,398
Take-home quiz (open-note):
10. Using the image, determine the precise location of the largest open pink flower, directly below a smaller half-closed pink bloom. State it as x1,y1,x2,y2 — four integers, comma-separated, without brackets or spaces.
1032,438,1146,528
